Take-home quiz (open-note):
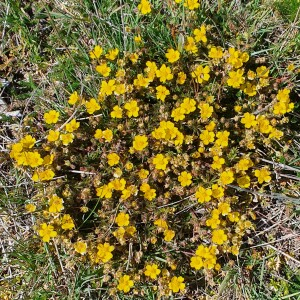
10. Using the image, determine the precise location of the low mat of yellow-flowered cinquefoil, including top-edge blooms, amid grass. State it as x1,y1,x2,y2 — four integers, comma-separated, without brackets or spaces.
10,0,294,296
